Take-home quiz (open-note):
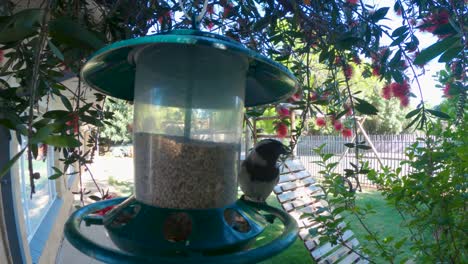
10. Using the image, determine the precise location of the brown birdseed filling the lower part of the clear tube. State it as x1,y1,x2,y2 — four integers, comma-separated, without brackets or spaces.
134,133,240,209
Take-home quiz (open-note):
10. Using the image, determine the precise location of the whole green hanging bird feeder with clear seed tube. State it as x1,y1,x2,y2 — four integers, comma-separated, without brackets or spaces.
65,30,297,263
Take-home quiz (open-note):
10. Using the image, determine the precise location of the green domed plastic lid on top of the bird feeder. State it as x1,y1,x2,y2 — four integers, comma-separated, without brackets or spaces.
81,29,298,107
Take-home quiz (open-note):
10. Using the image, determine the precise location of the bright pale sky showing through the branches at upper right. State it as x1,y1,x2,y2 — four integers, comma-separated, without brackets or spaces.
372,0,445,106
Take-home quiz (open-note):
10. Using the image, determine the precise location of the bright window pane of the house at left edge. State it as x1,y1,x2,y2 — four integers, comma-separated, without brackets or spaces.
19,139,57,242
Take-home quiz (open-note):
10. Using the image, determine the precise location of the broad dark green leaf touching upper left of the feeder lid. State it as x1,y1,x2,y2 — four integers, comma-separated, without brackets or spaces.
49,17,104,50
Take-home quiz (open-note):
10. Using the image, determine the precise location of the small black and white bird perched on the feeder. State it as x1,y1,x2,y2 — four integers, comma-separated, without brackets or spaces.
239,139,289,203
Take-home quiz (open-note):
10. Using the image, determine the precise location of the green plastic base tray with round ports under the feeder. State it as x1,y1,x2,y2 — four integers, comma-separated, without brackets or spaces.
65,197,297,263
